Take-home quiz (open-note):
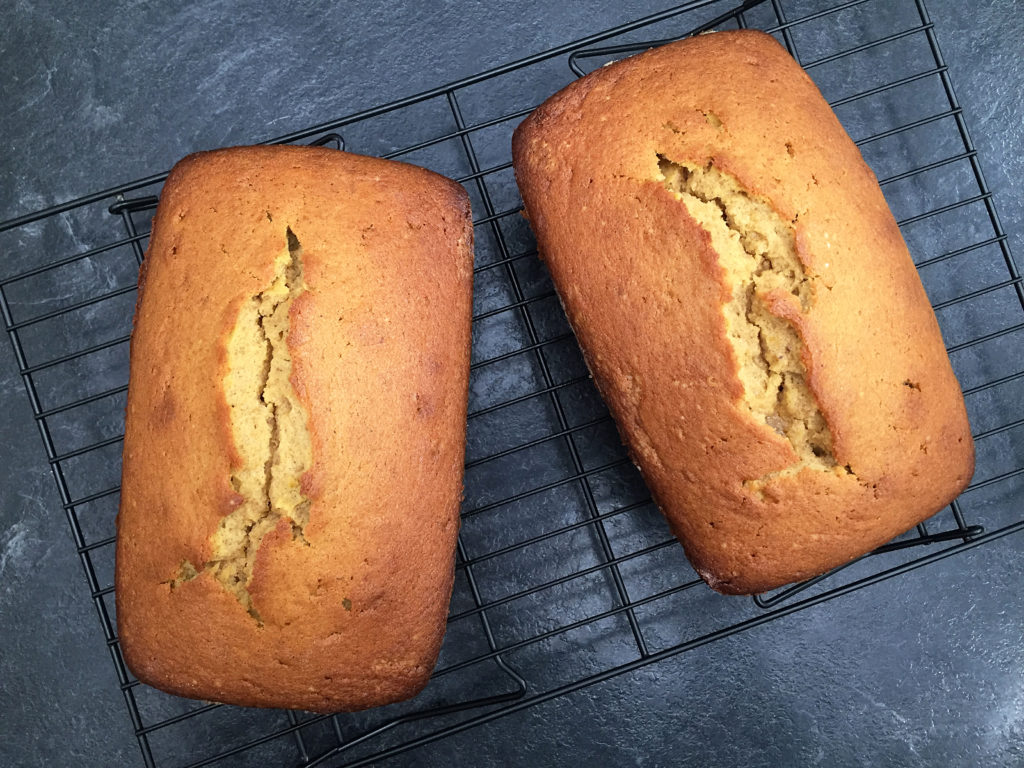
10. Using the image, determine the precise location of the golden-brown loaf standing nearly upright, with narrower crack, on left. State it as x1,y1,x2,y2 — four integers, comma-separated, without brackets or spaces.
116,146,472,712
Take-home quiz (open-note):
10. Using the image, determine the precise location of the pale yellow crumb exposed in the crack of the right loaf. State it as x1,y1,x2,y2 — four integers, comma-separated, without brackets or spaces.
658,156,836,482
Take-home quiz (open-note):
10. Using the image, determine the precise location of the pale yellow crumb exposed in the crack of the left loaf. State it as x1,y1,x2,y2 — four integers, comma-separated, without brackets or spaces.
170,228,312,621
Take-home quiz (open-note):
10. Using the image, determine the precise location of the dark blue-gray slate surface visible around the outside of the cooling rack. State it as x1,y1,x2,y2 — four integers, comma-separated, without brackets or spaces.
0,0,1024,766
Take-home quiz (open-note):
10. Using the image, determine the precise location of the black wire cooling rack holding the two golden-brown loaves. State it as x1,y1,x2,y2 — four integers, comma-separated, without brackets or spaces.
0,0,1024,767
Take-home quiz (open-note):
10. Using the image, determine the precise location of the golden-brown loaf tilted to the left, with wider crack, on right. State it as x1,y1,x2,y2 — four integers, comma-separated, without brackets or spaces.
513,32,974,594
